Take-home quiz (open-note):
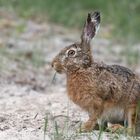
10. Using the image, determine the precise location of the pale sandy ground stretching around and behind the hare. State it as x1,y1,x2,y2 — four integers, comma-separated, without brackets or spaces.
0,10,140,140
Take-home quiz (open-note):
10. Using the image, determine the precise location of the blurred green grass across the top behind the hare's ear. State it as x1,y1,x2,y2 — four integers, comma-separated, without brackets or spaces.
0,0,140,44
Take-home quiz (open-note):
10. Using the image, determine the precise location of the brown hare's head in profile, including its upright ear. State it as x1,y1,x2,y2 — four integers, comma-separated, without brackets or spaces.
52,12,100,73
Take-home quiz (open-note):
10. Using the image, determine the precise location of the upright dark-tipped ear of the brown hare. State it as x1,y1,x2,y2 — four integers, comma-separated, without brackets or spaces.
81,12,100,44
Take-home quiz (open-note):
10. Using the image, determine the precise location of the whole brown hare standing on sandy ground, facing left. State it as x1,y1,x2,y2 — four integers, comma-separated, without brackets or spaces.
52,11,140,135
